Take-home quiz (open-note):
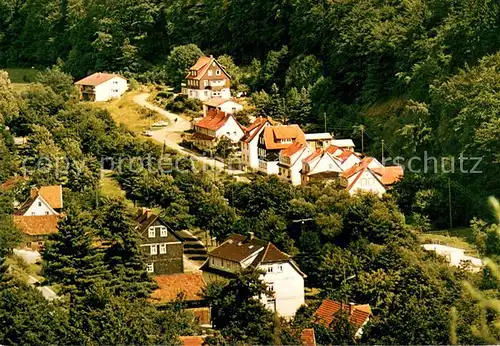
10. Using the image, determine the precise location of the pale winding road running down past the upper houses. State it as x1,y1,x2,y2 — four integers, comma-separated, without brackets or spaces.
133,93,249,178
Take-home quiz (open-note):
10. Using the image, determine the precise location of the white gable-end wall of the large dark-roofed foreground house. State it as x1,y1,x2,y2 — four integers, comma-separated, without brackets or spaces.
259,262,304,318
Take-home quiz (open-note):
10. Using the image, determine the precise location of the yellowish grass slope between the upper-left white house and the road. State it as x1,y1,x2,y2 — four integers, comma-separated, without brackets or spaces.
94,89,165,132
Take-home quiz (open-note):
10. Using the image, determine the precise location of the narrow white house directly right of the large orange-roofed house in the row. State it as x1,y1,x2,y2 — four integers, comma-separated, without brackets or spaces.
278,142,313,185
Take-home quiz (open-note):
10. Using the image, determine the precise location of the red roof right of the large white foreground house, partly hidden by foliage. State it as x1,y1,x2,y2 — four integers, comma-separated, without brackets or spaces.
314,299,372,328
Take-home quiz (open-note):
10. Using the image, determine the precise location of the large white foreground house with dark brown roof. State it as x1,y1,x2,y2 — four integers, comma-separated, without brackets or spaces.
201,233,306,318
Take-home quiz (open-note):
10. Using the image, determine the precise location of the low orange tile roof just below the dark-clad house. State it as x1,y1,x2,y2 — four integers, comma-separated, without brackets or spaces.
151,272,206,304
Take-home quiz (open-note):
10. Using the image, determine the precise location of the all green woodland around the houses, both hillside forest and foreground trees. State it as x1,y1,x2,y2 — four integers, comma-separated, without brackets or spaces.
0,0,500,345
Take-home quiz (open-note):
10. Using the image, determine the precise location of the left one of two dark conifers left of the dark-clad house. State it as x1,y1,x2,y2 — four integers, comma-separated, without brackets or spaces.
43,210,109,295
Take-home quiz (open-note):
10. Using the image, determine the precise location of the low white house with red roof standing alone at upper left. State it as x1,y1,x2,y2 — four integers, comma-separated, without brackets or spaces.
75,72,128,101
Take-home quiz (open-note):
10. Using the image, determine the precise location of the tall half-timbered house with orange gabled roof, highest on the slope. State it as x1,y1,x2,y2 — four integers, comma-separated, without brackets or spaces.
182,56,231,101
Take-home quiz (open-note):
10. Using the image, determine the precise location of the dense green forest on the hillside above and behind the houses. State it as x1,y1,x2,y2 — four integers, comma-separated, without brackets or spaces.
0,0,500,228
